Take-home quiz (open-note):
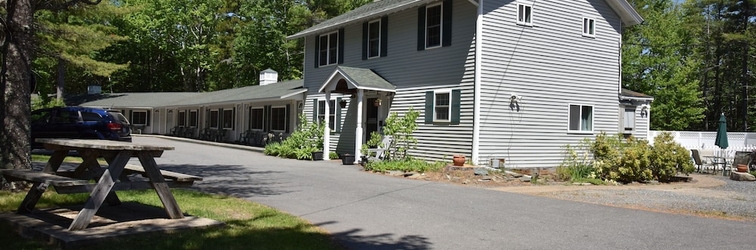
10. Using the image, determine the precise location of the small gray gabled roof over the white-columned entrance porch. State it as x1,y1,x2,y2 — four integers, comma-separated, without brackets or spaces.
318,66,396,92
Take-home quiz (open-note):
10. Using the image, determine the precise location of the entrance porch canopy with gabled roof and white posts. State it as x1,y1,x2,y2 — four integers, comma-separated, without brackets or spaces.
318,66,396,163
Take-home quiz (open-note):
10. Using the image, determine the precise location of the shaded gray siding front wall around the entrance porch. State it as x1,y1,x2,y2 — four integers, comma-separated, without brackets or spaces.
304,0,477,160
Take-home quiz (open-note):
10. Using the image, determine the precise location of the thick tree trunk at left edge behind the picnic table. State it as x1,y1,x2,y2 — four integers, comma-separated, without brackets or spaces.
0,0,36,169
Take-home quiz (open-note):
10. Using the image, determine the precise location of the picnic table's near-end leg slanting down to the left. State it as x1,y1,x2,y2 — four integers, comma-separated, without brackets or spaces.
68,151,131,231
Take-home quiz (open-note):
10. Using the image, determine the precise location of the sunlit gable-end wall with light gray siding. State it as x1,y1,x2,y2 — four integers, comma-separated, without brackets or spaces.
480,0,628,168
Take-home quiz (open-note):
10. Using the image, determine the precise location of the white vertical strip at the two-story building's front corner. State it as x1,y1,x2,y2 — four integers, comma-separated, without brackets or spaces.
472,0,490,167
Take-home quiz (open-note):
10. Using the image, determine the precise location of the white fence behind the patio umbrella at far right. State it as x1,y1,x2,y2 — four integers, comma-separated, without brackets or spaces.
648,131,756,162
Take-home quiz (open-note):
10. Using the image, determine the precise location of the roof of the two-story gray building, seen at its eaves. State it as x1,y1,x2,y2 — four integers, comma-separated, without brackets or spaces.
287,0,643,39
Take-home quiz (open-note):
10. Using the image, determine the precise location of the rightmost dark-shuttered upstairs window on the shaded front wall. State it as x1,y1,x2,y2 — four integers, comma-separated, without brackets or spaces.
417,0,453,50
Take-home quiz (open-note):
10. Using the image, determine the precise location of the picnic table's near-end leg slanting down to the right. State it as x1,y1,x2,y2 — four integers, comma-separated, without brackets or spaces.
139,152,184,219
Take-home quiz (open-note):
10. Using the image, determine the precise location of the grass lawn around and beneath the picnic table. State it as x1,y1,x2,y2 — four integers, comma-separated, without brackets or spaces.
0,158,341,250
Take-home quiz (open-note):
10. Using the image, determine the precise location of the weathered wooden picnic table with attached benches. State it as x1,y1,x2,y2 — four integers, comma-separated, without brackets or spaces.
3,139,202,231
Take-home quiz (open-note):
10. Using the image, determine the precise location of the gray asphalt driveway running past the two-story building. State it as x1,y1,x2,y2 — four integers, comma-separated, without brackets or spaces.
134,137,756,249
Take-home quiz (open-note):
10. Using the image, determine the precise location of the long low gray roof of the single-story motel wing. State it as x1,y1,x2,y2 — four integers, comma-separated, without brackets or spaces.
66,80,307,108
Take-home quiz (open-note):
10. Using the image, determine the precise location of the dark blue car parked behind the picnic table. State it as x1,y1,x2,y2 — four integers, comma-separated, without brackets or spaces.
31,107,131,148
